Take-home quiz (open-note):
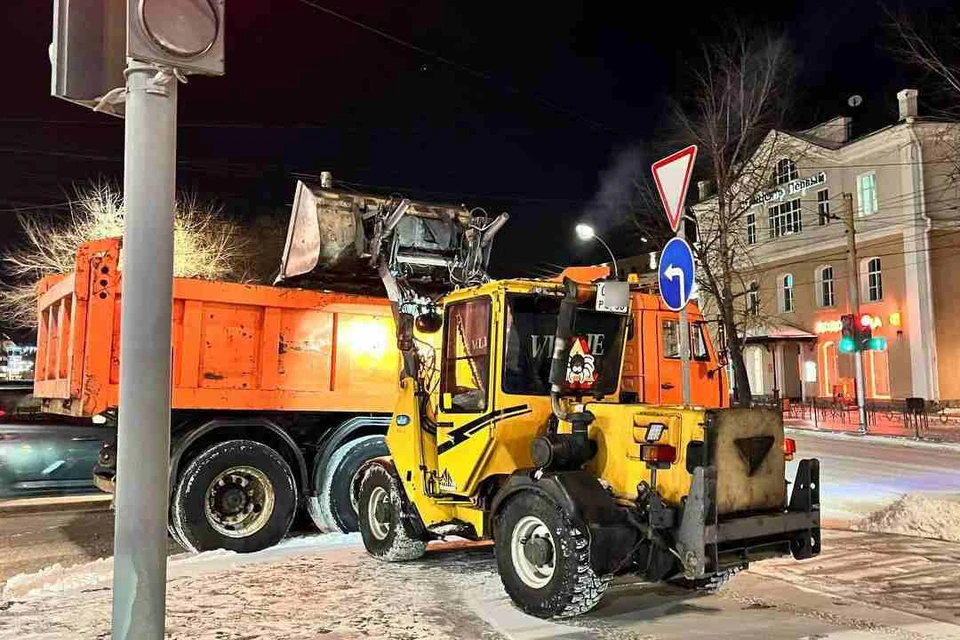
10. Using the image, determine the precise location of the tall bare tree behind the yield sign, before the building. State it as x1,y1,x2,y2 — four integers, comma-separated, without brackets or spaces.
674,30,793,406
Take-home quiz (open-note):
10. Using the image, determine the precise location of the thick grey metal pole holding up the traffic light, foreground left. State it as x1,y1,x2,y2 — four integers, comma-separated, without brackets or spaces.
113,62,177,640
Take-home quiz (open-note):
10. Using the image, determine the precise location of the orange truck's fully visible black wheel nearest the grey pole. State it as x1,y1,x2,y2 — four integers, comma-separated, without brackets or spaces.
171,440,297,553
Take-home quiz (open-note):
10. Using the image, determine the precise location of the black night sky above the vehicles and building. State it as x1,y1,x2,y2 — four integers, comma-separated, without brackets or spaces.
0,0,954,294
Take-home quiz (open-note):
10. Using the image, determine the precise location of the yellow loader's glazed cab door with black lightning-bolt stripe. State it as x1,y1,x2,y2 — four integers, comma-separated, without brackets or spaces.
437,296,496,493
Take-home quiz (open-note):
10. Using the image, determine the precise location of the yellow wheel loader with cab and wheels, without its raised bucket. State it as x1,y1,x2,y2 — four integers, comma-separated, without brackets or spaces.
353,280,820,617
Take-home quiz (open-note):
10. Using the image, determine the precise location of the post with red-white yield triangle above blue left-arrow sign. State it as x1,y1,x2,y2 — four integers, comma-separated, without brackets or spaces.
651,145,697,406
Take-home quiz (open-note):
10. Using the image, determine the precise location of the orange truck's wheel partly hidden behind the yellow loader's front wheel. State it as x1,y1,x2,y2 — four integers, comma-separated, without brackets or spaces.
307,434,390,533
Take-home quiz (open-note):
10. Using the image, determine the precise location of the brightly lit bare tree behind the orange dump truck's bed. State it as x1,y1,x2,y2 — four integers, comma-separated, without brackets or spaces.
0,184,256,328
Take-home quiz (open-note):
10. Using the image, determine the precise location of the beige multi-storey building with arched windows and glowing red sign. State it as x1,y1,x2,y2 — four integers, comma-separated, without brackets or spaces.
698,89,960,400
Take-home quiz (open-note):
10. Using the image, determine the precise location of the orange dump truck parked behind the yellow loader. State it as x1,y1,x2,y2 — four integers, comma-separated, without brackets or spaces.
35,239,727,551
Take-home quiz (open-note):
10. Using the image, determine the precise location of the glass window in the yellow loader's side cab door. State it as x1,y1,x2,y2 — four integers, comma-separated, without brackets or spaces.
440,298,490,413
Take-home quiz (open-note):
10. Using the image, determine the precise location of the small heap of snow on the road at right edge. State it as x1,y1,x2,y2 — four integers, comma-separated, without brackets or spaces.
853,493,960,542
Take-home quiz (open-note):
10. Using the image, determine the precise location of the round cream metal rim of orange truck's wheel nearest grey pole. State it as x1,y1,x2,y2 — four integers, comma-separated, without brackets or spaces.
203,466,276,538
